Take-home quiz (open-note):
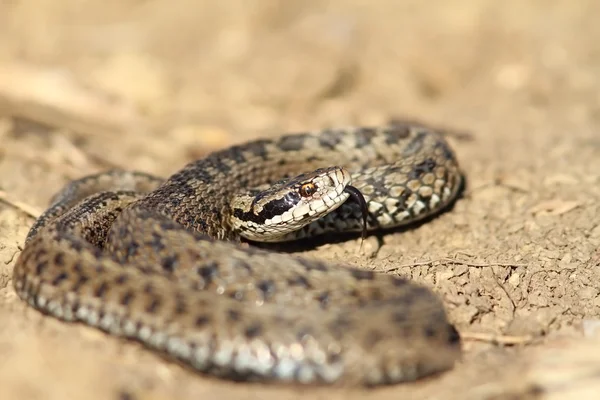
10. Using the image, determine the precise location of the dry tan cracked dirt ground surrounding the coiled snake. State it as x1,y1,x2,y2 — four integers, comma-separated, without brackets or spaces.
0,0,600,400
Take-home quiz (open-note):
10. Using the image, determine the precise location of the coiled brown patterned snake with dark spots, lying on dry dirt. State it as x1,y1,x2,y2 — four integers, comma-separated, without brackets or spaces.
13,123,464,387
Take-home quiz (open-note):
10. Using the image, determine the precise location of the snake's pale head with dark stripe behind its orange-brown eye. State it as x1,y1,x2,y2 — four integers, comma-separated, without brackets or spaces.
231,167,364,242
